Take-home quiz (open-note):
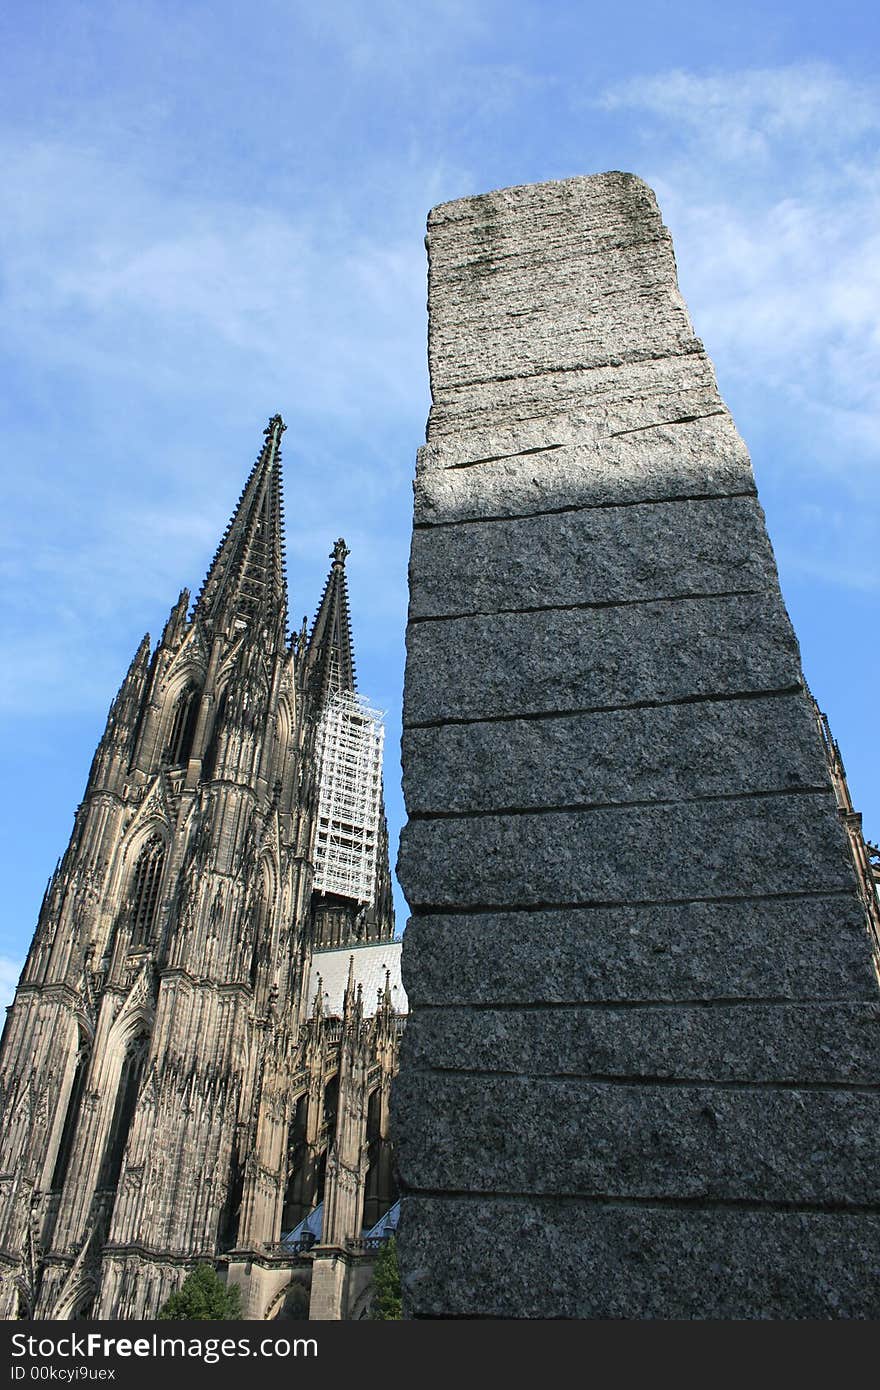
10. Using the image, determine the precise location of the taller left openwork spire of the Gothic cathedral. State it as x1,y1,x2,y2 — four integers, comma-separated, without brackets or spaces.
196,416,286,626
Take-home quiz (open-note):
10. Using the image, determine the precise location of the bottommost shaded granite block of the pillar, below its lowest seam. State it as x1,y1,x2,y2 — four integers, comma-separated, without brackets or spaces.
399,1195,880,1319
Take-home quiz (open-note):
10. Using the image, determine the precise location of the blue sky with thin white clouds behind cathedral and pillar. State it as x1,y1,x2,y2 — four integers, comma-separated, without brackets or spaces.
0,0,880,994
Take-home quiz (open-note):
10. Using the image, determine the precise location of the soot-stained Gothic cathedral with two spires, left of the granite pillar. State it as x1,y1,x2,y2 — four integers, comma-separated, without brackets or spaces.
0,416,406,1318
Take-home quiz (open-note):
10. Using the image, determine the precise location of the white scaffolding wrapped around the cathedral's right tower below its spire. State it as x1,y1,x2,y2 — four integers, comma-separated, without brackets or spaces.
314,694,385,906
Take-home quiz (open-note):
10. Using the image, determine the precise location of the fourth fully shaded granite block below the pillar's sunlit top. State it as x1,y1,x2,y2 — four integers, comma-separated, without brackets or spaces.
398,792,852,909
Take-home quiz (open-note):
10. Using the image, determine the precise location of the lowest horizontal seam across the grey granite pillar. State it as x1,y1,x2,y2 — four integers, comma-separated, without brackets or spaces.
403,1183,880,1216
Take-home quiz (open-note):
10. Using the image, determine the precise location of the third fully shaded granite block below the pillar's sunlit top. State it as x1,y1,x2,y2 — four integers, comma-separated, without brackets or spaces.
403,695,827,816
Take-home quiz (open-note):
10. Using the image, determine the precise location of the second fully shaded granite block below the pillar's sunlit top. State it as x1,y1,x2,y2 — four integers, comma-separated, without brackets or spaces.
403,594,799,726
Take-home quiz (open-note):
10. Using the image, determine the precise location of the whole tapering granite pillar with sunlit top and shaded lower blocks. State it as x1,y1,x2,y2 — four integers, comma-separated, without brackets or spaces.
395,174,880,1318
